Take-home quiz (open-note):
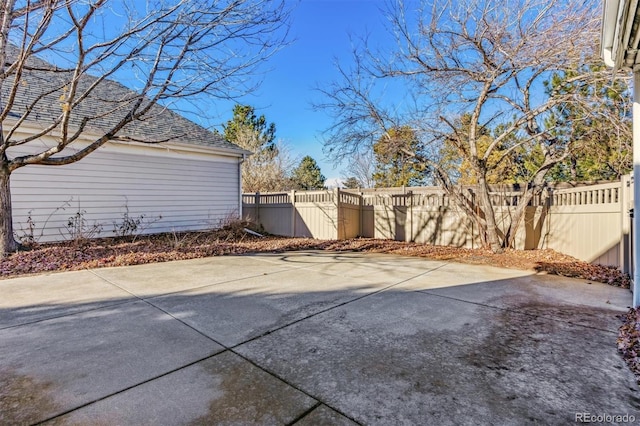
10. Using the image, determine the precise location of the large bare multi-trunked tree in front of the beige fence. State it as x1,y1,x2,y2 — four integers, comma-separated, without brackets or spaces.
317,0,610,251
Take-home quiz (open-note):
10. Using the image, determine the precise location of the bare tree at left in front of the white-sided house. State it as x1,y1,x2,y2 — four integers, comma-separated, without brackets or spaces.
0,0,288,256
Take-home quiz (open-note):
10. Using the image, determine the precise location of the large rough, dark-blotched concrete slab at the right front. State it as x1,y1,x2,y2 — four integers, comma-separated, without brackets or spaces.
237,290,640,425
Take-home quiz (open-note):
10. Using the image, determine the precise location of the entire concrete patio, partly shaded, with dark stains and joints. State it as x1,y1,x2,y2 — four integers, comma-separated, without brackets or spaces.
0,252,640,425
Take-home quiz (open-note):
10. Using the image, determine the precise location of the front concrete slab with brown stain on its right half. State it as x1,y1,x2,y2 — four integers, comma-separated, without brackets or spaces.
50,351,317,426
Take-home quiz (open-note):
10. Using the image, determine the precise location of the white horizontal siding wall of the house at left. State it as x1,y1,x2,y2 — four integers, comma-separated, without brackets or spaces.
11,136,240,242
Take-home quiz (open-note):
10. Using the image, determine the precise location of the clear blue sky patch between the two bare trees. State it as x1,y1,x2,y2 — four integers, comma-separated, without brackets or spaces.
210,0,385,183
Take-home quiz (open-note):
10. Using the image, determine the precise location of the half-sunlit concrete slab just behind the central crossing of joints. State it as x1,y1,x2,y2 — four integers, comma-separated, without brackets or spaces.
149,269,384,347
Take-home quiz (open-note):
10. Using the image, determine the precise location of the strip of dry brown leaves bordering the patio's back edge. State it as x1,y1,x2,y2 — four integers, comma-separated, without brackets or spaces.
0,229,630,288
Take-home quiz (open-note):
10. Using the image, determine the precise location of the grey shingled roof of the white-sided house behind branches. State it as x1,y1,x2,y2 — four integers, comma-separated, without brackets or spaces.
2,48,247,154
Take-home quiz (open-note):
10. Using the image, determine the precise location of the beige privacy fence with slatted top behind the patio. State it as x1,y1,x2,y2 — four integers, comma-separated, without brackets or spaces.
243,177,633,271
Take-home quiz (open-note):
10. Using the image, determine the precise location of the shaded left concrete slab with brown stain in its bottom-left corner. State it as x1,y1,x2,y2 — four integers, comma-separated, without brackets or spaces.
0,300,223,424
